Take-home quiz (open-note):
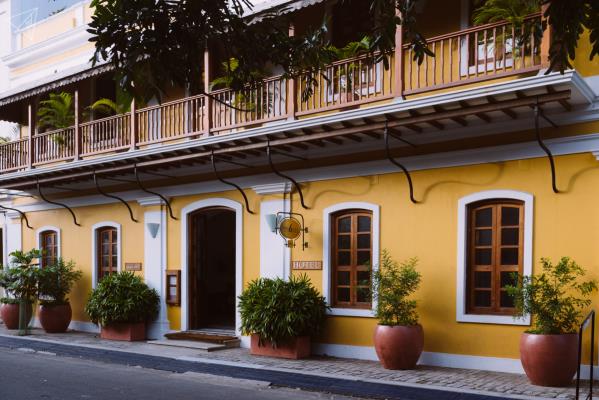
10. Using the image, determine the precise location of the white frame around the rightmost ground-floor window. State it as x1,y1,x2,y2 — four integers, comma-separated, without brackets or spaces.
456,190,534,326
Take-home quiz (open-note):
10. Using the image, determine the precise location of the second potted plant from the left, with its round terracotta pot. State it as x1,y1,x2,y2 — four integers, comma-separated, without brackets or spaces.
38,258,82,333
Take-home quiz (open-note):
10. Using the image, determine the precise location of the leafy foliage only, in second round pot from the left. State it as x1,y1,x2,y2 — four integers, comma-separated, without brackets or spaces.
38,258,82,305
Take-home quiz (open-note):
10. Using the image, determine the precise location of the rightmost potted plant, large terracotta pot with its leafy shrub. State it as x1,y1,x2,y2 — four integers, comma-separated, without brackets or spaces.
507,257,597,386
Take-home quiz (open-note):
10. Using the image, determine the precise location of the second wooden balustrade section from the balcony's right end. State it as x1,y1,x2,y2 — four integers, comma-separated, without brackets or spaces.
296,54,394,115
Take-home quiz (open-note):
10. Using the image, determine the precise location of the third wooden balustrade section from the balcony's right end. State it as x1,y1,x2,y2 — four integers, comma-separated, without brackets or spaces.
211,76,288,131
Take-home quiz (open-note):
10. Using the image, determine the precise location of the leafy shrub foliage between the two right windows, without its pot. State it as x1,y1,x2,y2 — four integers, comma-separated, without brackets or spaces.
372,250,421,326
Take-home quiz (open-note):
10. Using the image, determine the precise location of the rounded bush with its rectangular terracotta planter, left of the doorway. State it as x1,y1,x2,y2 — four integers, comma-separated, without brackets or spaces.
85,271,160,341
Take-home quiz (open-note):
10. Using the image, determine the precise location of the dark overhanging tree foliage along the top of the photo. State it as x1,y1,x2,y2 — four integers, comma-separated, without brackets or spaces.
88,0,599,100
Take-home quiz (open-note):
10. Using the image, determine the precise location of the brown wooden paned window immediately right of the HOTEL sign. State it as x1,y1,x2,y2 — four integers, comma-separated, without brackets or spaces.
331,210,372,308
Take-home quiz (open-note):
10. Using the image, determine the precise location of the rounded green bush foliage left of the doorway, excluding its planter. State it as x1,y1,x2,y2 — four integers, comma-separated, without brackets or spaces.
85,271,160,326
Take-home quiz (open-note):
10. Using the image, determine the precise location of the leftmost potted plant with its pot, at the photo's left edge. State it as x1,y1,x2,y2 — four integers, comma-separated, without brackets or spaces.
0,249,41,329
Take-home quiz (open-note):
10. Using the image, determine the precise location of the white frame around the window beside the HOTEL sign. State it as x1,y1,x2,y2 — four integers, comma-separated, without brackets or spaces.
322,202,381,318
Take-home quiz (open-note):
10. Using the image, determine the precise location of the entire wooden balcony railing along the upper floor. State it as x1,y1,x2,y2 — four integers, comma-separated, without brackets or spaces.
0,13,547,173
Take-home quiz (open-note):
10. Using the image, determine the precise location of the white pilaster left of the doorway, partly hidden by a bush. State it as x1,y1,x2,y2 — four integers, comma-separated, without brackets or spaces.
139,199,170,339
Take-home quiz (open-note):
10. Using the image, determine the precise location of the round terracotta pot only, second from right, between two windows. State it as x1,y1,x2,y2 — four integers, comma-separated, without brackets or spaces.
374,325,424,369
